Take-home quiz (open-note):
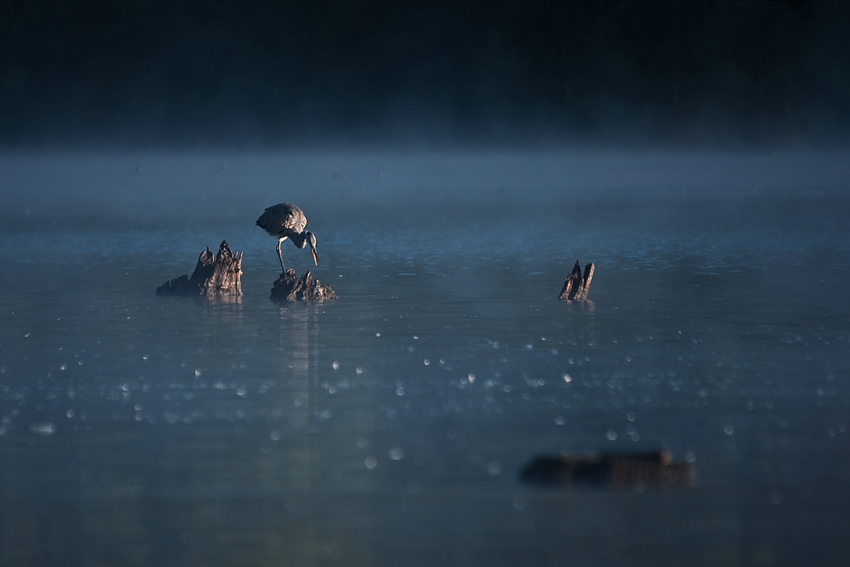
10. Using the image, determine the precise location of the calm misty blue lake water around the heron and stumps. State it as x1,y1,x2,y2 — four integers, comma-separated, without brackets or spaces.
0,153,850,566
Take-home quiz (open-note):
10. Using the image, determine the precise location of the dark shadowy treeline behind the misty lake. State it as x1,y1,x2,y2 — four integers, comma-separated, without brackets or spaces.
0,0,850,147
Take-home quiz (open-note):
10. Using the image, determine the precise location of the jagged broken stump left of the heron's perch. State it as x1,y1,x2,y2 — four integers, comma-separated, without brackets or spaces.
156,240,242,299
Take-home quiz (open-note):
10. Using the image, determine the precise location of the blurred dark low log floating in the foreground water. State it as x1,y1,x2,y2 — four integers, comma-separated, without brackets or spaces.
520,449,697,489
